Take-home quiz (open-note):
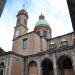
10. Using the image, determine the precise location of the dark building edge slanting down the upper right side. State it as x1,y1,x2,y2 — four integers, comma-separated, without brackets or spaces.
67,0,75,34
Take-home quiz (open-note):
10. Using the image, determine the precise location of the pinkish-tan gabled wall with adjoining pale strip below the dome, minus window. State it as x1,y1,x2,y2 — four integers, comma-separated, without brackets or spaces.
12,32,47,55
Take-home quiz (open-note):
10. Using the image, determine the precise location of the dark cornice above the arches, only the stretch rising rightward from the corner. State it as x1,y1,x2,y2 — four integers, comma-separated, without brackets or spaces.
28,46,75,57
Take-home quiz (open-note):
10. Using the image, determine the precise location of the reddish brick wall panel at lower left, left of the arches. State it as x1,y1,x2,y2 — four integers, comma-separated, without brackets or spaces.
11,57,24,75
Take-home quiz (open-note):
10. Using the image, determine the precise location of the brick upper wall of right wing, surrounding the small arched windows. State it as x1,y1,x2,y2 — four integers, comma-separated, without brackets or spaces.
50,33,74,48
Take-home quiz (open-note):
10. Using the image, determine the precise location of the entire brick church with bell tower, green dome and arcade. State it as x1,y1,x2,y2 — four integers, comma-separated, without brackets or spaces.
0,9,75,75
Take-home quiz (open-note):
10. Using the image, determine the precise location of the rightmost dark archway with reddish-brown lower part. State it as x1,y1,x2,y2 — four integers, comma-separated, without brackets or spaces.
58,56,74,75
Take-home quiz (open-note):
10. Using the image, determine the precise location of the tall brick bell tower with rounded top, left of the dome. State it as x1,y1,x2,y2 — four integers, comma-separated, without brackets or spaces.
13,9,28,39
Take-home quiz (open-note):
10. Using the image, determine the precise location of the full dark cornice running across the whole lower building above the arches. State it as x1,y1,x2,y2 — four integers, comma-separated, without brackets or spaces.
1,46,75,58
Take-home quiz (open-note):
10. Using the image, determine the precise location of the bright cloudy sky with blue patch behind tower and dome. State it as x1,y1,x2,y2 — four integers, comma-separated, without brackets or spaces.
0,0,73,51
